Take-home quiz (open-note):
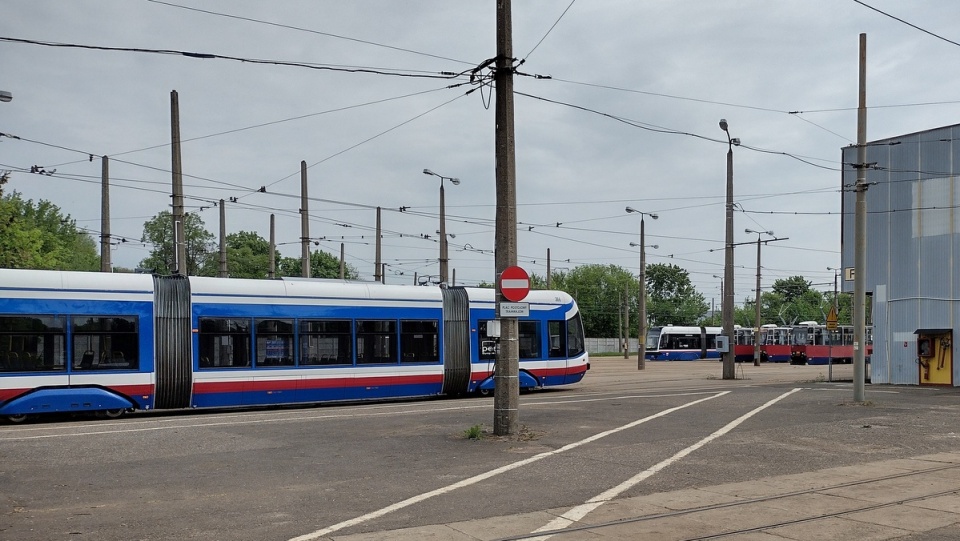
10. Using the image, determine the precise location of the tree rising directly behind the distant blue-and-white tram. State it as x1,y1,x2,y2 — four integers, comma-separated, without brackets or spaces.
646,263,709,325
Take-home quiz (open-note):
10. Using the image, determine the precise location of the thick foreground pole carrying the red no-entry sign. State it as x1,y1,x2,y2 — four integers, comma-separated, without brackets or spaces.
493,0,520,436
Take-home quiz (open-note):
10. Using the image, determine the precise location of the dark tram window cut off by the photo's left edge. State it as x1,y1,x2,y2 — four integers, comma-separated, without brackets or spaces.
0,315,67,372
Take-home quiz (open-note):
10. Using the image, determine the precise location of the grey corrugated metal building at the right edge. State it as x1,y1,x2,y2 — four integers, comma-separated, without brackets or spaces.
841,124,960,386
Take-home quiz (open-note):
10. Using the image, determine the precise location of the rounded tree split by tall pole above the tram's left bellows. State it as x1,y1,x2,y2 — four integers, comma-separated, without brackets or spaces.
140,210,219,276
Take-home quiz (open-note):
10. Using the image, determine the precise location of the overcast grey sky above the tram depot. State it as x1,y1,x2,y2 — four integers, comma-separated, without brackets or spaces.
0,0,960,304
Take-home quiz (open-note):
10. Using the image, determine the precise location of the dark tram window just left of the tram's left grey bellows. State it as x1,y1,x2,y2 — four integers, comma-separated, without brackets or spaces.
72,316,140,370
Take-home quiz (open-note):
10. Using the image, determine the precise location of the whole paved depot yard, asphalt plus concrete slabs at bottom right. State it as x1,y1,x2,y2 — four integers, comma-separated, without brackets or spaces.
0,357,960,541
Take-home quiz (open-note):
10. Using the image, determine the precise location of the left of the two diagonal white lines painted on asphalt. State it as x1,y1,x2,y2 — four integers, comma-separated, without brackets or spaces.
290,391,730,541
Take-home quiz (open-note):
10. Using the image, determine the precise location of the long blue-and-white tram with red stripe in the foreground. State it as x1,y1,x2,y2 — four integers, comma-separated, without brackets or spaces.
0,269,589,421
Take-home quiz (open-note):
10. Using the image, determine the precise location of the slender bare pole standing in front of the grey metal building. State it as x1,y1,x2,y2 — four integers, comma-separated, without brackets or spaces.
853,34,867,396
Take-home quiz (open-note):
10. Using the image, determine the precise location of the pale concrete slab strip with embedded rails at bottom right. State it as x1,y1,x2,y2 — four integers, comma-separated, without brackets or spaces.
323,452,960,541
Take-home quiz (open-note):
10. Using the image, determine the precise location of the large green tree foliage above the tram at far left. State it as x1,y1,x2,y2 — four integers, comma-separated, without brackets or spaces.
0,192,100,271
